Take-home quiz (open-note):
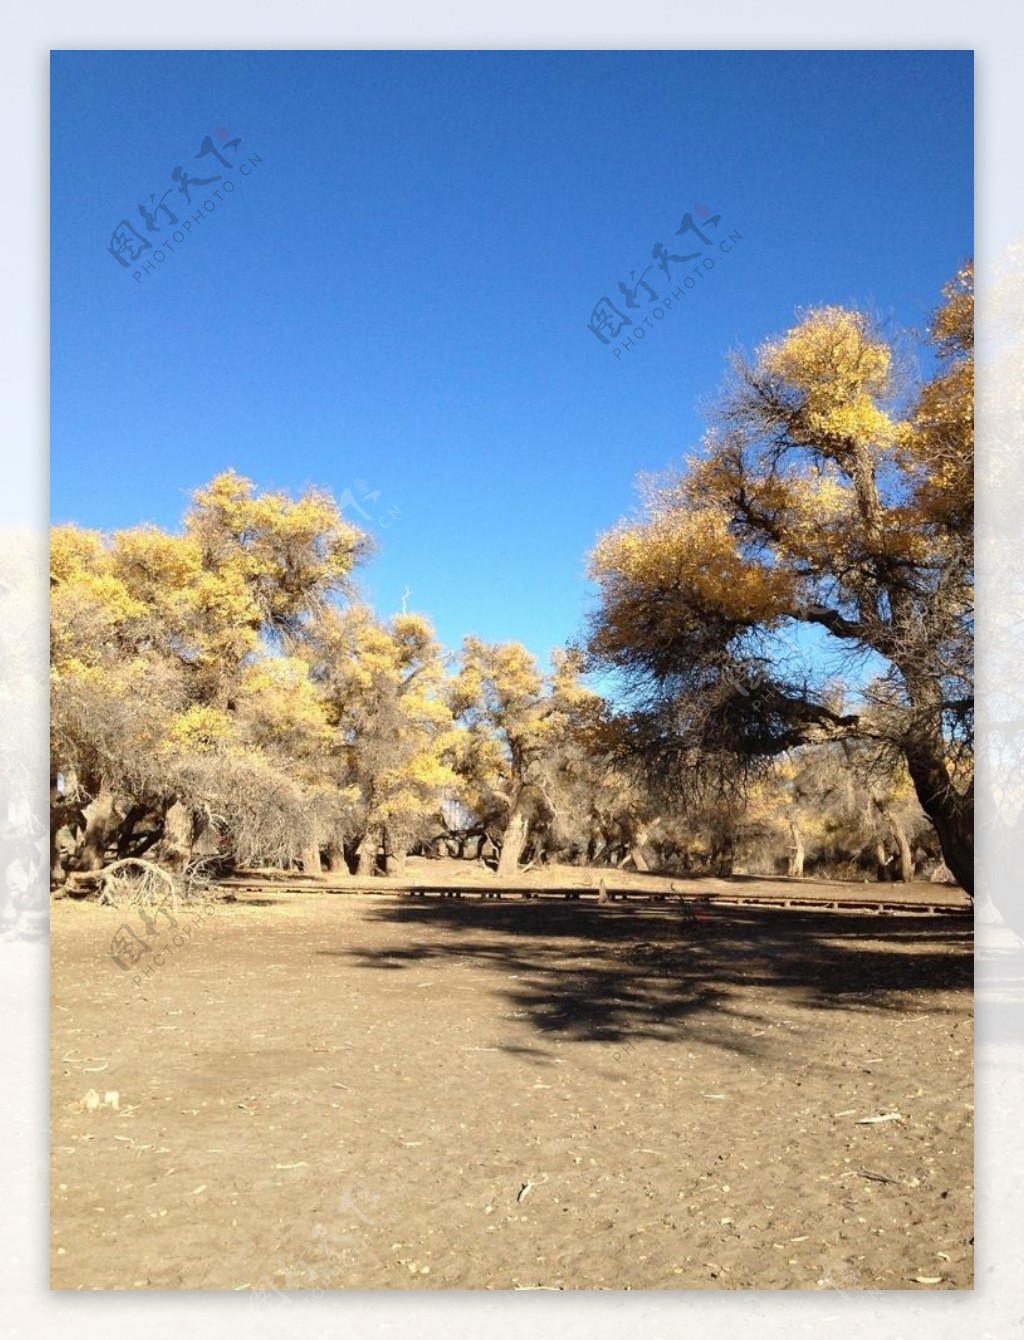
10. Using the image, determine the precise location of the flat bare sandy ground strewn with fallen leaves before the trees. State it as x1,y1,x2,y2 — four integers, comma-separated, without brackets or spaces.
51,863,973,1291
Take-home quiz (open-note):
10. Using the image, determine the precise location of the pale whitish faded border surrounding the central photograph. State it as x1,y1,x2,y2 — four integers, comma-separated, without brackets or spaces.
10,0,1024,1340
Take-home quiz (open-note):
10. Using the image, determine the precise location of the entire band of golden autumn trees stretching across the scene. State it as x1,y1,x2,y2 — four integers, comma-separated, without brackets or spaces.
51,265,973,892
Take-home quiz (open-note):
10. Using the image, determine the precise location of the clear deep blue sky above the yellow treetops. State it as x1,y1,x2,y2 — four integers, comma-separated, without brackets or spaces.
51,51,973,670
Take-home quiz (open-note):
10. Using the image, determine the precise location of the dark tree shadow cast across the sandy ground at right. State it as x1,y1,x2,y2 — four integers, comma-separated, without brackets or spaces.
320,900,973,1055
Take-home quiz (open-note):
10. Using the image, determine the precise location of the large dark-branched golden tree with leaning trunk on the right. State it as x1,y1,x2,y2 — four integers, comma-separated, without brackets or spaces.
588,265,973,892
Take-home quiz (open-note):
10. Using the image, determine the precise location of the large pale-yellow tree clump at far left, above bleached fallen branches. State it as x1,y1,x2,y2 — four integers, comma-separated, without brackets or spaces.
51,470,369,878
